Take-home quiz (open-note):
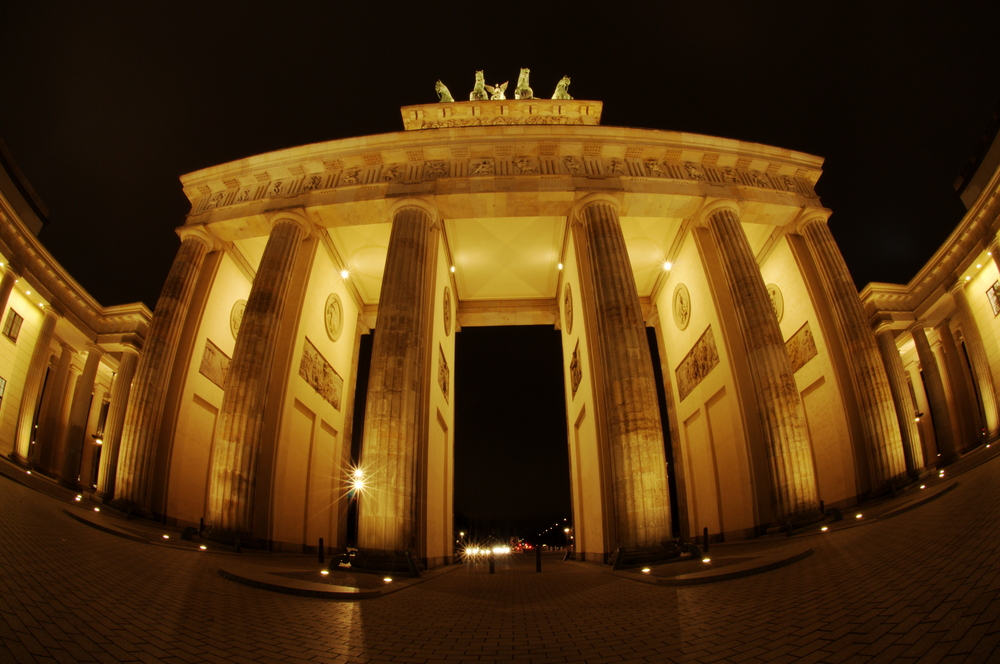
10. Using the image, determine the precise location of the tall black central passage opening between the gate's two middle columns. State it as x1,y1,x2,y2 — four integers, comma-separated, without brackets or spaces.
453,325,573,545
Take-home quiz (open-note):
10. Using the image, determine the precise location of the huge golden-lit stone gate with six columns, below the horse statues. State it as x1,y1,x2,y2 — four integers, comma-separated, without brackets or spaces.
19,100,952,566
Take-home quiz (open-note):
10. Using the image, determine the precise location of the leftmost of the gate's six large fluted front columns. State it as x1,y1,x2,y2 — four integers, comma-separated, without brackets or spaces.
115,227,213,512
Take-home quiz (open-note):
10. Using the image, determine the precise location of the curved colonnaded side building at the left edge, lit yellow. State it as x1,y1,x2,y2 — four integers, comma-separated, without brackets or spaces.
0,146,152,495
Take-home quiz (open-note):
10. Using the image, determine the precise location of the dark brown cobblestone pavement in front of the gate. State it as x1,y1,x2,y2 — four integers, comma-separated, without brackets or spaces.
0,452,1000,664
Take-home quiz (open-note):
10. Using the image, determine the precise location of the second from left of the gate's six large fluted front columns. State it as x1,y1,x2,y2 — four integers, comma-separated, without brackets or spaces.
206,214,310,540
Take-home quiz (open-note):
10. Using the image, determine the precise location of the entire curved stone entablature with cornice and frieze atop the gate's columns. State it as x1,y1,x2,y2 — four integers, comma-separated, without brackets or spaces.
181,126,823,214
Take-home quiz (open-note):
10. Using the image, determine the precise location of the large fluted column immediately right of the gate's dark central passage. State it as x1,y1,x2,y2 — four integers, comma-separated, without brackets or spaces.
579,199,671,550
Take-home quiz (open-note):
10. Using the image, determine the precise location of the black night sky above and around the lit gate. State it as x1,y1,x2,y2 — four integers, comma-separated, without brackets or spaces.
0,0,1000,540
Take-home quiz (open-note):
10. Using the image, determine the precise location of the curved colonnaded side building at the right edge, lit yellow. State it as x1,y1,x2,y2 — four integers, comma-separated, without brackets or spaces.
861,126,1000,478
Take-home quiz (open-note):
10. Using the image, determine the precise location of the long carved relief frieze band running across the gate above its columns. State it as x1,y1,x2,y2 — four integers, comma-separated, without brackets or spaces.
188,146,816,212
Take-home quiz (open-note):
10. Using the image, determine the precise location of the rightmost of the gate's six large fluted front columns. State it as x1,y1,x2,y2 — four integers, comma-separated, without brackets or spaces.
800,217,906,489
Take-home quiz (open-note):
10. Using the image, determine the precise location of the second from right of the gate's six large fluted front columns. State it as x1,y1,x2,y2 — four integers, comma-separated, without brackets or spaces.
706,207,819,522
